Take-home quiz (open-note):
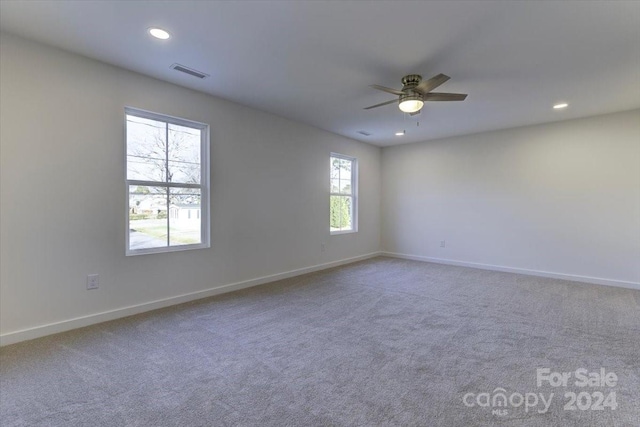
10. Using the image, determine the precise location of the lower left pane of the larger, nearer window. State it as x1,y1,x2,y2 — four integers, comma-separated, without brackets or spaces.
129,185,167,250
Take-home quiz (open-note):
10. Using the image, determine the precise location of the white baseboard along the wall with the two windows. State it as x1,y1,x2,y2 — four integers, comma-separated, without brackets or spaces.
0,252,380,346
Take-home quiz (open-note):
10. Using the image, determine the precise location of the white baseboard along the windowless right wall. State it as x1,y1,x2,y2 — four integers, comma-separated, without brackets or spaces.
380,252,640,290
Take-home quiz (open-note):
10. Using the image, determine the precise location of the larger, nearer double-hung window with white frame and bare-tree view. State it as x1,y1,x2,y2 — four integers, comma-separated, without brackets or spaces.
125,108,209,255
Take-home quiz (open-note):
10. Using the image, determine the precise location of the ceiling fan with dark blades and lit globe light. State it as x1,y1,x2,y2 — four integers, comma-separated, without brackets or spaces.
365,74,467,116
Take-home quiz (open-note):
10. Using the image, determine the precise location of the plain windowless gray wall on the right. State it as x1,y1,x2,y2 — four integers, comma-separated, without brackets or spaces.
382,110,640,287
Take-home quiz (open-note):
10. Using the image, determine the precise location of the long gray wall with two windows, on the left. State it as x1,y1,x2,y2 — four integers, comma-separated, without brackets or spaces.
0,34,380,335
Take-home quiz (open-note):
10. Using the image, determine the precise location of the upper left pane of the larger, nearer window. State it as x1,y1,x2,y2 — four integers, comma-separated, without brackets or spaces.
127,115,167,182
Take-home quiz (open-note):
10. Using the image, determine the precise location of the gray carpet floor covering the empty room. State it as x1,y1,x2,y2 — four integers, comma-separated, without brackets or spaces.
0,258,640,427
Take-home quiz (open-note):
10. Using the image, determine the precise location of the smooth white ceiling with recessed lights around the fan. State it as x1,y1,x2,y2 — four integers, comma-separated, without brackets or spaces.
0,0,640,146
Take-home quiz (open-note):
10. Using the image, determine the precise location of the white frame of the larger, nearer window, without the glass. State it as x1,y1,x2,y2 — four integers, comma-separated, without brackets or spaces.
124,107,211,256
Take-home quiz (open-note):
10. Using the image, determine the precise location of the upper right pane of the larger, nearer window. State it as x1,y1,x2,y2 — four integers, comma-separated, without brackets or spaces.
168,124,202,184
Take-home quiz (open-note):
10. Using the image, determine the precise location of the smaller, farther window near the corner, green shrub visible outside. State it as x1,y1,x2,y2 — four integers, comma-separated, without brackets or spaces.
329,153,358,234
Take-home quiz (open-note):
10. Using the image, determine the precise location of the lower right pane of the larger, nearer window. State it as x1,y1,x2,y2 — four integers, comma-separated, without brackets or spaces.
169,188,202,246
